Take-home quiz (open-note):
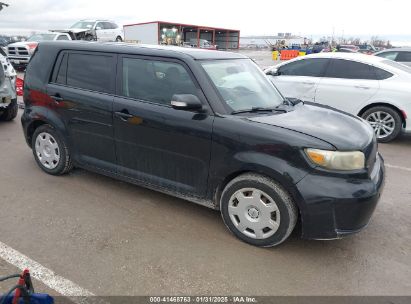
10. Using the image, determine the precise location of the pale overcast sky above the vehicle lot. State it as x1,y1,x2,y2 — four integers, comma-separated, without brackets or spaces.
0,0,411,40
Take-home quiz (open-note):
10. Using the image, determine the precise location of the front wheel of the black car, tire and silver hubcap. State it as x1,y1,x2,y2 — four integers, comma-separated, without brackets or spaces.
220,173,298,247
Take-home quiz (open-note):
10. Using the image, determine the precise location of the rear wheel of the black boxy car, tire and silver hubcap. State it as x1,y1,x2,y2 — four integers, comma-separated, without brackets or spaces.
32,125,73,175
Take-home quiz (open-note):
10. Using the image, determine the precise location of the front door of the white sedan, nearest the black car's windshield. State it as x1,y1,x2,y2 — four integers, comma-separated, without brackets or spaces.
269,58,328,101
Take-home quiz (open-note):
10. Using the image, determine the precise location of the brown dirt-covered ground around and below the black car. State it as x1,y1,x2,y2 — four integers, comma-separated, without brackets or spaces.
0,110,411,295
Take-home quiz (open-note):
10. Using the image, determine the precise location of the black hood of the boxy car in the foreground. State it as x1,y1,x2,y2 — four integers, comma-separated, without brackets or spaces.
247,103,374,151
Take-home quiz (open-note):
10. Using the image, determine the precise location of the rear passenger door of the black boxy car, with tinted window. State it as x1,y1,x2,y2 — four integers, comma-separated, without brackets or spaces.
47,51,116,171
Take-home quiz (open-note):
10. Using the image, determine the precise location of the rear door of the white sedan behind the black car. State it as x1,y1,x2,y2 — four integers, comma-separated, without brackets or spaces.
315,58,379,115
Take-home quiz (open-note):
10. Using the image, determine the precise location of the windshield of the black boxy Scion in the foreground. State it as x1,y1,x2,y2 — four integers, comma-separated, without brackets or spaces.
201,59,284,111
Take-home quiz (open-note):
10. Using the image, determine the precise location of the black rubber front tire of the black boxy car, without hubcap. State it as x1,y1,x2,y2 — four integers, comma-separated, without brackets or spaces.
220,173,298,247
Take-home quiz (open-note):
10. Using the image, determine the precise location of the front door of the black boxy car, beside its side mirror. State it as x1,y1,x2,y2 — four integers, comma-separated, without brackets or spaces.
114,56,214,197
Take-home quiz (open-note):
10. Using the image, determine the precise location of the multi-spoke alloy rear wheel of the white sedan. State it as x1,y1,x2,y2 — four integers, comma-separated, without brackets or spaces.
361,106,402,143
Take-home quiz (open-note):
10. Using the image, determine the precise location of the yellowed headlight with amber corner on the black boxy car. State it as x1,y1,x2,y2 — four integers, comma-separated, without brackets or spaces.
305,149,365,171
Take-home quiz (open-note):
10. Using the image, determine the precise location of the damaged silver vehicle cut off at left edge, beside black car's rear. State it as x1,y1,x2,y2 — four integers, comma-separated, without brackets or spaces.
0,49,18,121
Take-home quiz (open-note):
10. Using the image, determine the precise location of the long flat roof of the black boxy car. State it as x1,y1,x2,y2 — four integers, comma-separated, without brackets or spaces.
39,41,248,60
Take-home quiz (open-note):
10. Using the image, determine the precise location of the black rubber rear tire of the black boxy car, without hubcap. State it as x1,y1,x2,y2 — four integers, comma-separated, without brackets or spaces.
31,124,73,175
